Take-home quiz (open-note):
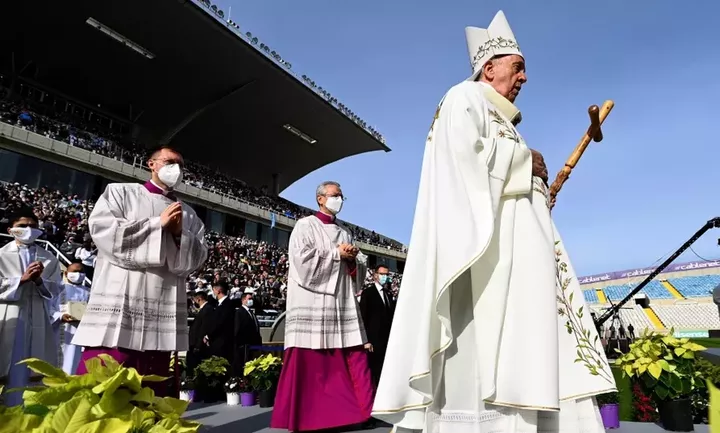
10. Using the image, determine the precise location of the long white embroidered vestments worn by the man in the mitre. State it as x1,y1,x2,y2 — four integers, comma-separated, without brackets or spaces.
373,82,615,433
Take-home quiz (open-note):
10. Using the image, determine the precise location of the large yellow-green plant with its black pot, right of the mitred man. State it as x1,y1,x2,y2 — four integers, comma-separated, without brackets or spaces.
615,330,705,431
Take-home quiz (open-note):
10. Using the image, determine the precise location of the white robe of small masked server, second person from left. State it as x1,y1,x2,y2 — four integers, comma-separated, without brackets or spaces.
50,283,90,374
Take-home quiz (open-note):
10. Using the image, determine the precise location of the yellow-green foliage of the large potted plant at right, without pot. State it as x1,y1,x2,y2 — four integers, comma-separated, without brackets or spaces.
615,330,705,401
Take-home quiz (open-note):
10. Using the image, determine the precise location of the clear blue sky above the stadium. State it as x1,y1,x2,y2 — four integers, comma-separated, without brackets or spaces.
224,0,720,274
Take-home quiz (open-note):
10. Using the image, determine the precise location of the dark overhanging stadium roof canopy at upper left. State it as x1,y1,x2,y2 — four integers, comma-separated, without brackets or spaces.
0,0,390,190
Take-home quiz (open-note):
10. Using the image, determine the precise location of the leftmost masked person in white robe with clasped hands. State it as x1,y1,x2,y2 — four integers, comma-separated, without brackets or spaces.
0,208,63,406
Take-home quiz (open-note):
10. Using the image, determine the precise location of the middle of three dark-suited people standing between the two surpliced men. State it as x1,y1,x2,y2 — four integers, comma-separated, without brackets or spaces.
203,280,235,365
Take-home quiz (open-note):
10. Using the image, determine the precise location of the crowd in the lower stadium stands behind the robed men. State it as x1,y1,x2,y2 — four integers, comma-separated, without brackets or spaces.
0,183,402,310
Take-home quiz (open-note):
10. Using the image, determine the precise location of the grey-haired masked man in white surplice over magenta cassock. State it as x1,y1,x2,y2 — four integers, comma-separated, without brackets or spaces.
270,182,373,432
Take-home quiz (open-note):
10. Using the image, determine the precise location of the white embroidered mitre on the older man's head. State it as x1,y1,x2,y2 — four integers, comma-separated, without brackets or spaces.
465,11,522,81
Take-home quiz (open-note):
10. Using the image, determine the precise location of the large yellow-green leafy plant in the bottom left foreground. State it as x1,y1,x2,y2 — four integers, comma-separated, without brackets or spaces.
0,355,200,433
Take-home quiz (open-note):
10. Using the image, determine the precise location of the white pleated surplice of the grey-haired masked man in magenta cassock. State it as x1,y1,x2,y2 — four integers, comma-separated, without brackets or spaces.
285,216,367,349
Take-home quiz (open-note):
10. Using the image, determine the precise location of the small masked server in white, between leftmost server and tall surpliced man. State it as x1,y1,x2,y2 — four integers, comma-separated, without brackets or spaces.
50,263,90,374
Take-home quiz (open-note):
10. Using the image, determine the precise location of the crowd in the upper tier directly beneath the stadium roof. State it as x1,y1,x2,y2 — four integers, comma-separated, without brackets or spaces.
0,88,403,251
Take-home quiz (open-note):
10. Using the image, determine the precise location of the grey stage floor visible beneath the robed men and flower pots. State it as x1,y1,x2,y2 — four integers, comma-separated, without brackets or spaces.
185,403,710,433
